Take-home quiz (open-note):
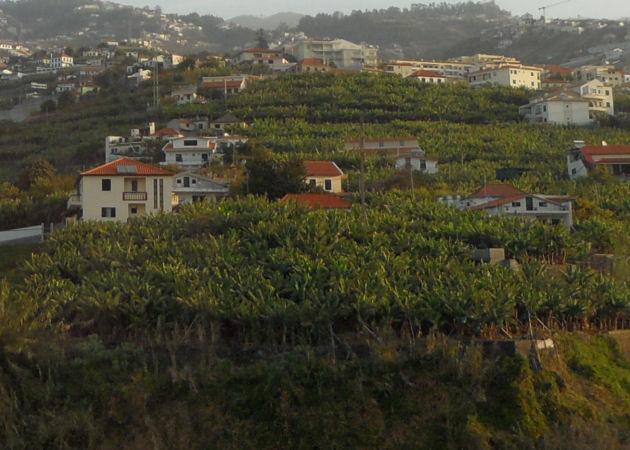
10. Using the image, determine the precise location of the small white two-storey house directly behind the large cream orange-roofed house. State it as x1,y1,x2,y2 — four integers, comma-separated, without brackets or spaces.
161,137,216,170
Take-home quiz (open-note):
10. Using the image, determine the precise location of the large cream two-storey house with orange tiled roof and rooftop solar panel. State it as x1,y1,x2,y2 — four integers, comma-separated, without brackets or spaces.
68,158,175,222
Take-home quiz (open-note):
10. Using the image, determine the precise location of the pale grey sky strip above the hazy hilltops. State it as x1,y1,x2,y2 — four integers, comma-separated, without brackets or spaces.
114,0,630,19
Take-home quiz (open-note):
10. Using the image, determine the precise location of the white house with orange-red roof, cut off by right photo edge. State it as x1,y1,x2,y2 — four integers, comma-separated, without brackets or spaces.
567,141,630,181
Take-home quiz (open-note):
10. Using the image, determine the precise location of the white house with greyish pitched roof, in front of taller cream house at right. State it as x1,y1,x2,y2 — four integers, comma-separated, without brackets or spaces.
519,92,591,125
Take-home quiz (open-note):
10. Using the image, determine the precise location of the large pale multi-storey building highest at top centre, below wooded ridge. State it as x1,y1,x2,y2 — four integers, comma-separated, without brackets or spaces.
285,39,378,70
